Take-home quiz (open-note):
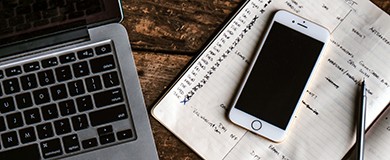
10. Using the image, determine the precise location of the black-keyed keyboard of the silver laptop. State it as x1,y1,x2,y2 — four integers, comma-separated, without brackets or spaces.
0,41,136,159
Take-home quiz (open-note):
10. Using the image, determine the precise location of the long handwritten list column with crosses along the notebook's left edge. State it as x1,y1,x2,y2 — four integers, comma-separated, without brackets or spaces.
173,0,271,105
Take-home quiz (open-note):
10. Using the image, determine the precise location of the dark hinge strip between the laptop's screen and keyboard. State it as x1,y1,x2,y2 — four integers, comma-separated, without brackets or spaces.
0,26,90,57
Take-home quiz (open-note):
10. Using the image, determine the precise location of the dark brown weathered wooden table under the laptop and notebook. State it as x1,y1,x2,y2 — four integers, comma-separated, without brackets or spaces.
122,0,390,159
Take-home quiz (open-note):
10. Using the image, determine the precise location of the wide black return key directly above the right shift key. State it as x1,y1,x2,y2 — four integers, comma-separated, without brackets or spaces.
93,88,123,107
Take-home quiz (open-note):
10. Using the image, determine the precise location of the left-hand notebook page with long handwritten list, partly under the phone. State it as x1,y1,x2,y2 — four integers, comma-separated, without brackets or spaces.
153,0,388,159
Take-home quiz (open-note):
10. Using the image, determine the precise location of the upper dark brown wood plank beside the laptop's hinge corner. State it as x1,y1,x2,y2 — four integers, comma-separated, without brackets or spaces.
122,0,242,55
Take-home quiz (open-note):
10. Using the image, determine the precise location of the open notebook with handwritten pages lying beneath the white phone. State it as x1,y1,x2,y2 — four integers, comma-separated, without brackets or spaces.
152,0,390,160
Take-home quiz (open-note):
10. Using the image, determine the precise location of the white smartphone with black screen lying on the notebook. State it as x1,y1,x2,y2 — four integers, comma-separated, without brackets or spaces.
228,10,330,142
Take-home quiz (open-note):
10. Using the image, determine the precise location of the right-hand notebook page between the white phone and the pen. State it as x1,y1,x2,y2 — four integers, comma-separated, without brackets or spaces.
222,1,390,160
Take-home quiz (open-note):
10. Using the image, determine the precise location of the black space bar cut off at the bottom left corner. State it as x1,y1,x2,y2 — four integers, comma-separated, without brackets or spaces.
0,144,41,159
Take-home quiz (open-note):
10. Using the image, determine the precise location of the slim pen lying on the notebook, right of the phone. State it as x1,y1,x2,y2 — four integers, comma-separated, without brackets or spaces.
356,79,367,160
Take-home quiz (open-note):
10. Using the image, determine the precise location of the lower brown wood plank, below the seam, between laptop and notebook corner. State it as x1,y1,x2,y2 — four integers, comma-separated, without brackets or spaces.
133,52,200,159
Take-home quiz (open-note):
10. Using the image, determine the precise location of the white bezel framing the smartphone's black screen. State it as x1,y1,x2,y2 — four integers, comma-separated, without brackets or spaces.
228,10,330,142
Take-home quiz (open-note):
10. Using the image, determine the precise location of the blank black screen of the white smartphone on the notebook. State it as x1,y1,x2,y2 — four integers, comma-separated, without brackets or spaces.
235,22,324,129
